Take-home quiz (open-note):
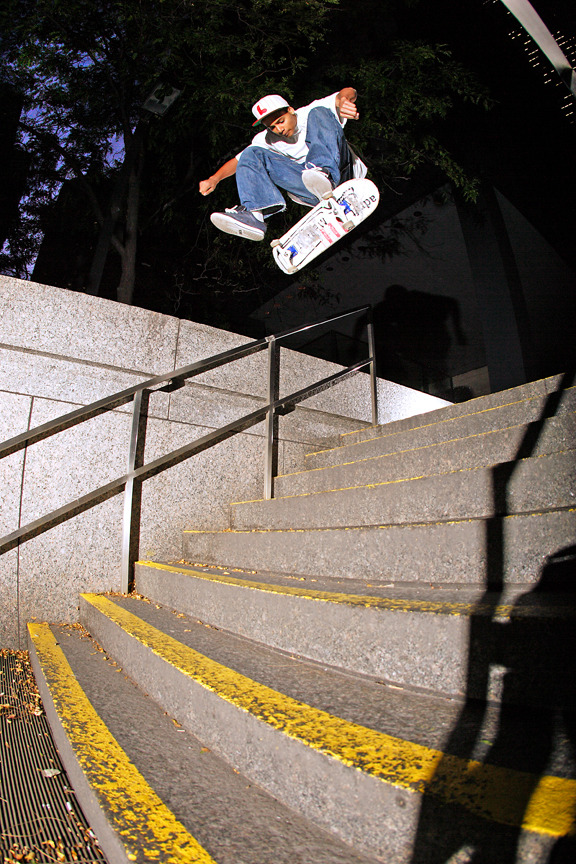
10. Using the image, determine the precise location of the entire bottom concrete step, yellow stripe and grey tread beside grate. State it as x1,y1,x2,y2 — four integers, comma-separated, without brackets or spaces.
30,625,375,864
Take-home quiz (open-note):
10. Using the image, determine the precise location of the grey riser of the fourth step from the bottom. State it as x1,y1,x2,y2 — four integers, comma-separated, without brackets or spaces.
183,509,576,587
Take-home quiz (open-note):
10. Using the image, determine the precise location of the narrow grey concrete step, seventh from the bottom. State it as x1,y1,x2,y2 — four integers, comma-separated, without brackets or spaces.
306,387,576,468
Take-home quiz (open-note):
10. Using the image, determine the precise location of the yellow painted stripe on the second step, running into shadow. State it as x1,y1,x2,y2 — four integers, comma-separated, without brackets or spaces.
81,594,576,837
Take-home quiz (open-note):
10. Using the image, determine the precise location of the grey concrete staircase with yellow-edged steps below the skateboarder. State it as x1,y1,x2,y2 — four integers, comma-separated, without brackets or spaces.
30,376,576,864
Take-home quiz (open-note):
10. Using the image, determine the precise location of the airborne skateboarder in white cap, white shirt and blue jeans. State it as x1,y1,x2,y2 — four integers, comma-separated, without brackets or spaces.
200,87,367,240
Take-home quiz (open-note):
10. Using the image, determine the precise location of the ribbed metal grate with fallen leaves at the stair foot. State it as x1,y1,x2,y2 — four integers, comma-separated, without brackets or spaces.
0,651,106,864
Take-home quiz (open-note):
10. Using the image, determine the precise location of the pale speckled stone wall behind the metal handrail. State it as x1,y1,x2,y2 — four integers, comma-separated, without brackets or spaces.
0,276,444,647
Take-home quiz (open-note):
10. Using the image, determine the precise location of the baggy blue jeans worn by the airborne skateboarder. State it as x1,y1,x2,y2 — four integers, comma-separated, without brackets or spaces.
236,107,350,217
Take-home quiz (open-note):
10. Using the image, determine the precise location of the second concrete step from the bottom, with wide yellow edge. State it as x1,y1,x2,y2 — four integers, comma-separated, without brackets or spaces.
81,595,576,864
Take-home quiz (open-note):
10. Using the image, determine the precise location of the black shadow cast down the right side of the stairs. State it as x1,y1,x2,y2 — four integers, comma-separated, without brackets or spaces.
411,374,576,864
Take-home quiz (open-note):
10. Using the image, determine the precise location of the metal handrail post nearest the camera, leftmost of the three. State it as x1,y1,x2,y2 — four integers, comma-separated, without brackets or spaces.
120,390,150,594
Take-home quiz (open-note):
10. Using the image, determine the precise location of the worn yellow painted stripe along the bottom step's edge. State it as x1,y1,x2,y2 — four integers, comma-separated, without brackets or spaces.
28,623,215,864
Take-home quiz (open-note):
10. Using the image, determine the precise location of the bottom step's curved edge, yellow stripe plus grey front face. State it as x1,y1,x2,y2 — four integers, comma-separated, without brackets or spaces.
28,623,215,864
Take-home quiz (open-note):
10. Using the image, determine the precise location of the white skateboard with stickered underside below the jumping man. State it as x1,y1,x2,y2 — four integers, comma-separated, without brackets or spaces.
270,179,380,274
